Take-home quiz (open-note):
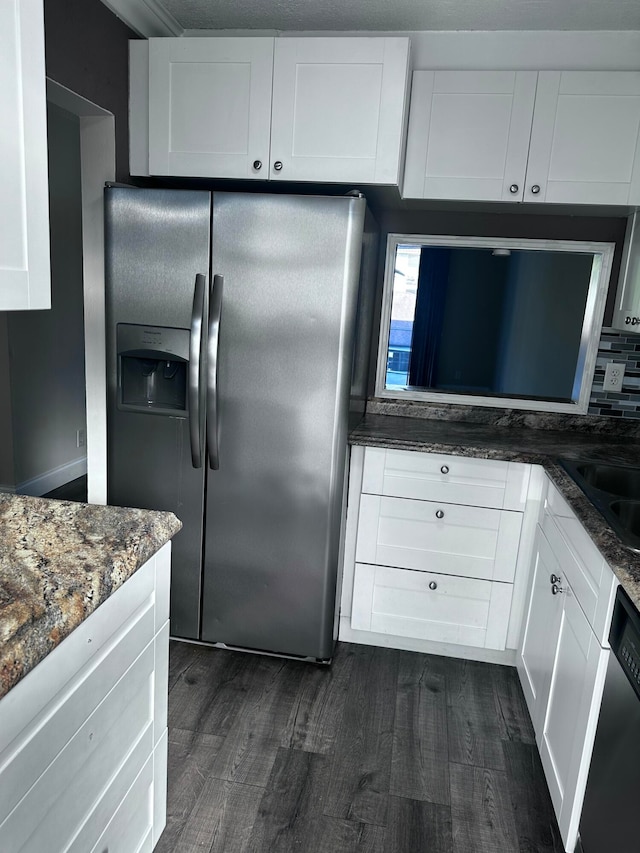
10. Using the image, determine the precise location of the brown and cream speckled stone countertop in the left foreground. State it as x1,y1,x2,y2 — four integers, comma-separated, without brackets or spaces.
0,494,182,697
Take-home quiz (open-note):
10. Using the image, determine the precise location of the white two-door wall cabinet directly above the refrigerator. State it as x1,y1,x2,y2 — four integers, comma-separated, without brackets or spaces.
138,37,409,184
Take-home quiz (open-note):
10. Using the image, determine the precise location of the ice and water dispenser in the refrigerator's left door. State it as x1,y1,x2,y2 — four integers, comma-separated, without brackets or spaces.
117,323,190,417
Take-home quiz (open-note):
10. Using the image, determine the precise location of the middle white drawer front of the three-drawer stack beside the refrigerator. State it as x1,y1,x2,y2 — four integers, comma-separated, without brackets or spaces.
356,495,522,582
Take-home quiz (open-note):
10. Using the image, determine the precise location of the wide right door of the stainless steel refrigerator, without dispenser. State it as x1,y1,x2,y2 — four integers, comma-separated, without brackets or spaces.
202,193,365,659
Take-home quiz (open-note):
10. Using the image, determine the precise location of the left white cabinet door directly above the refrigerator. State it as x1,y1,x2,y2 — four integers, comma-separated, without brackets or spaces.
149,38,274,179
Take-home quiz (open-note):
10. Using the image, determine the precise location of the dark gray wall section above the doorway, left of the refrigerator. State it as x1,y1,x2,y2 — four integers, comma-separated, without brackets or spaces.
44,0,137,182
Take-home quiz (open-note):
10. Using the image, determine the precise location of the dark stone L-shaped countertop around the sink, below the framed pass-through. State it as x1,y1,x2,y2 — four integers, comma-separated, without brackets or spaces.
349,413,640,610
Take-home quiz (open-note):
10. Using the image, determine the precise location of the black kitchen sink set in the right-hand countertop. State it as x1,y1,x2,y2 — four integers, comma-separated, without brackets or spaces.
559,459,640,551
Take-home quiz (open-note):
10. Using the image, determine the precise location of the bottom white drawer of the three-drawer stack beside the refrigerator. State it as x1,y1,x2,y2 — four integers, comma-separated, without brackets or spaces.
351,563,513,649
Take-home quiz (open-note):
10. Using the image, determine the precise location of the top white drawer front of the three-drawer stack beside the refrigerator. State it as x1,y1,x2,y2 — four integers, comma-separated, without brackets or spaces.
362,447,530,511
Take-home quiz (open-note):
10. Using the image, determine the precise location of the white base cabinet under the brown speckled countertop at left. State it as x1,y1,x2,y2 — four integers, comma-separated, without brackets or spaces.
0,544,170,853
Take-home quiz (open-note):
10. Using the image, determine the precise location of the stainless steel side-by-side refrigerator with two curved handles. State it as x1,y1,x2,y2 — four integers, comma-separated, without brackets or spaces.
105,186,377,660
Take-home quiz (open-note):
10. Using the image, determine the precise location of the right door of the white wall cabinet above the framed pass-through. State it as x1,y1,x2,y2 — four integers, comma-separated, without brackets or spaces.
524,71,640,205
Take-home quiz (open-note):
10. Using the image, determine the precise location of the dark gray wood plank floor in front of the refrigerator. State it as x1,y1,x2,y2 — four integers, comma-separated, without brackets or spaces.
156,642,563,853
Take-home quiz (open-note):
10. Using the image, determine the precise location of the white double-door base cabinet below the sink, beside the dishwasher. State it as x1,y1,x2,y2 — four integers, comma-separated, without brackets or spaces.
517,486,617,853
